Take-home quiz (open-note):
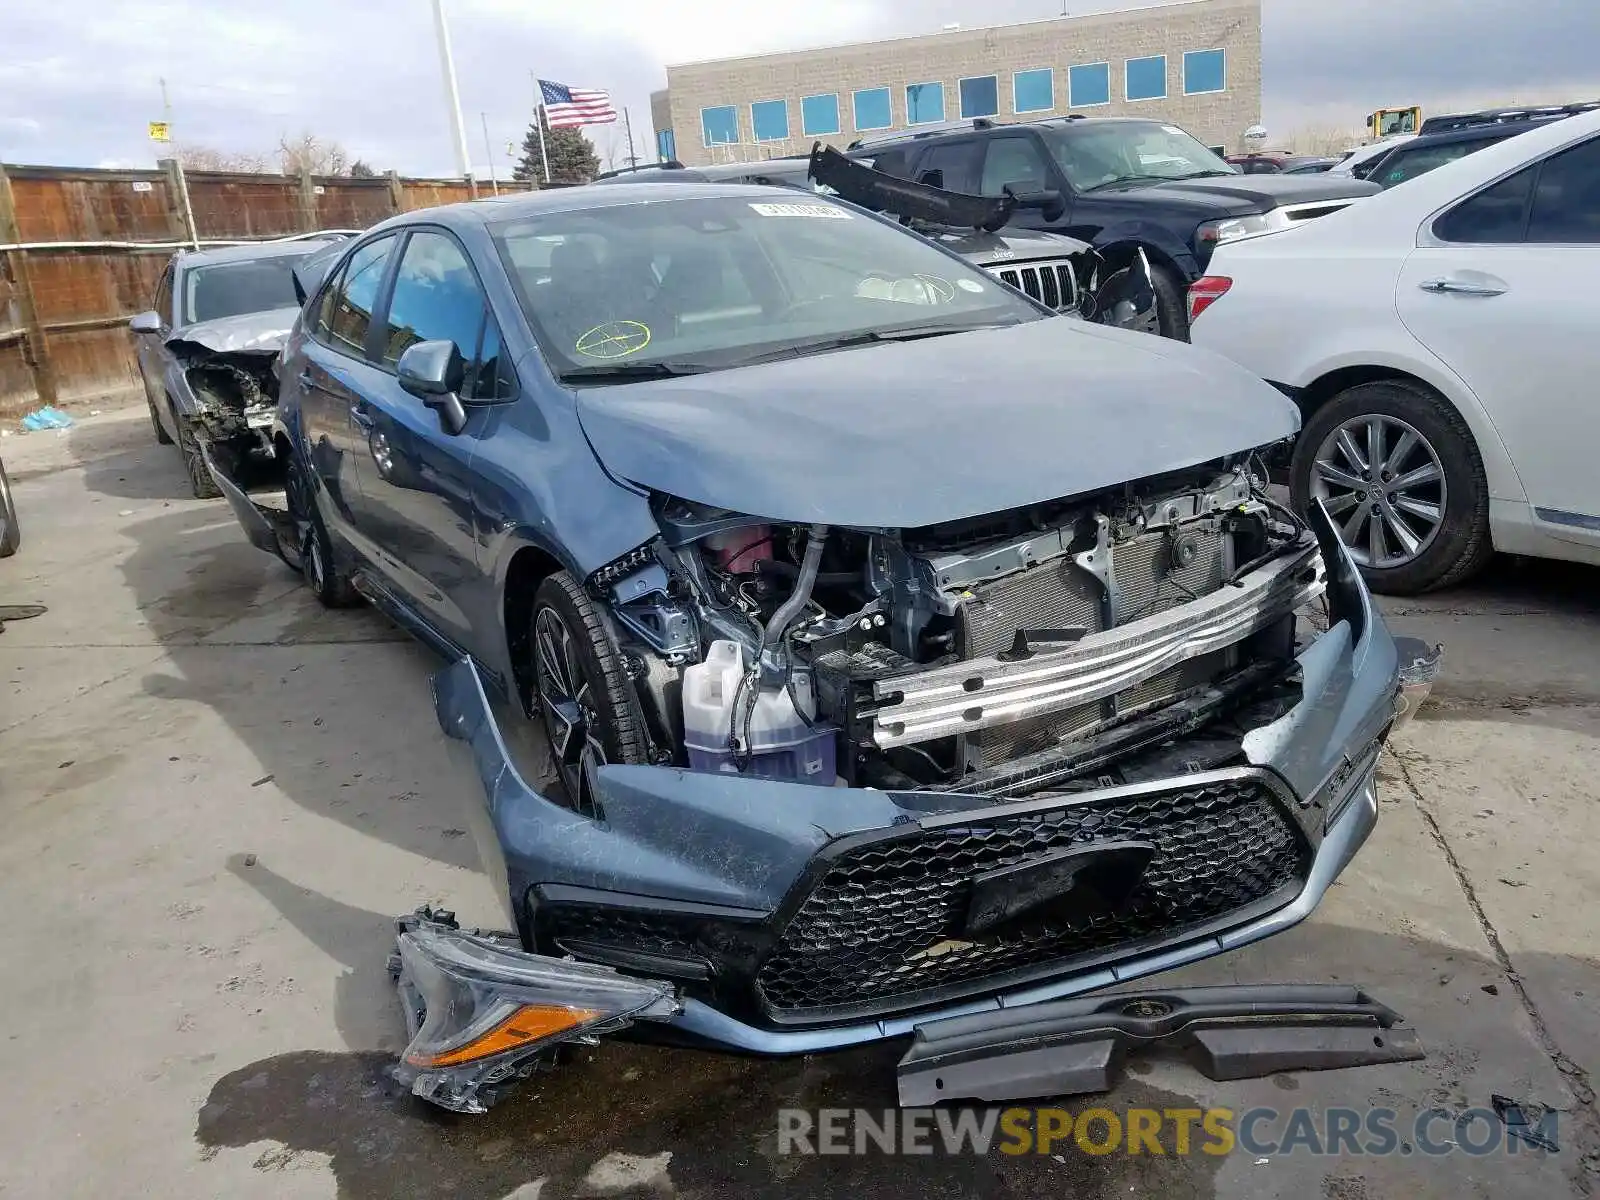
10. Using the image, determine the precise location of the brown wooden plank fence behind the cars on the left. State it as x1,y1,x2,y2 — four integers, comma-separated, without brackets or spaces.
0,162,537,416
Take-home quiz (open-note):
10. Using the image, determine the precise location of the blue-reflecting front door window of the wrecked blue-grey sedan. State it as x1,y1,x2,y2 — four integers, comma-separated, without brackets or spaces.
382,229,499,400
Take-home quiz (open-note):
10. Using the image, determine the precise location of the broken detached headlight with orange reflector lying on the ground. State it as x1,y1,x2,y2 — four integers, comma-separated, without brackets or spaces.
395,917,682,1112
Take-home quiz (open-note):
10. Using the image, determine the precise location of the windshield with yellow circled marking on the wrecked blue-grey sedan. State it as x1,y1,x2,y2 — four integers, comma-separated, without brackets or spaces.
493,192,1046,378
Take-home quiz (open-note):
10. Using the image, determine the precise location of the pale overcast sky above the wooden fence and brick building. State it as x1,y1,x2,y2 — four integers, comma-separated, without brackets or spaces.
0,0,1600,176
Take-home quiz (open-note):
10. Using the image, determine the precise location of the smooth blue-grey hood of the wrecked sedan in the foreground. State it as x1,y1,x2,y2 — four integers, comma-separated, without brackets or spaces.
578,318,1299,528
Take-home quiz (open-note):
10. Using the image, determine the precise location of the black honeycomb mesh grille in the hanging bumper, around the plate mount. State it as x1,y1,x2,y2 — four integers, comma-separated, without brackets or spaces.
757,779,1306,1014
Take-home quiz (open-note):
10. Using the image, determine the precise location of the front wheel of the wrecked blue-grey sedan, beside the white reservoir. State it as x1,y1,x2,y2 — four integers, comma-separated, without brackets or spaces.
528,571,650,813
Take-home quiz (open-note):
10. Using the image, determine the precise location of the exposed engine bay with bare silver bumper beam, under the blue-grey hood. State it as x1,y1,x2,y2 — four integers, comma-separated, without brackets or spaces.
589,456,1323,809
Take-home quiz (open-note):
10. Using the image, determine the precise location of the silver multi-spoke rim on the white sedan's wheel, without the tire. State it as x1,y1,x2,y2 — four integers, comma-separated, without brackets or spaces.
1310,413,1448,568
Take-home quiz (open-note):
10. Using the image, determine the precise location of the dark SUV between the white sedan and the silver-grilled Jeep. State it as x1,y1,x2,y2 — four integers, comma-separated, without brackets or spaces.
850,115,1378,338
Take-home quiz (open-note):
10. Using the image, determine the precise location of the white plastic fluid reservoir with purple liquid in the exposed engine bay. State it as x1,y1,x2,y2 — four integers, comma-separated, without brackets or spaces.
683,642,834,787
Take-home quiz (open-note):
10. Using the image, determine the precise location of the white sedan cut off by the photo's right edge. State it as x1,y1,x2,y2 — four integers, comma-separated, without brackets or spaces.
1189,112,1600,594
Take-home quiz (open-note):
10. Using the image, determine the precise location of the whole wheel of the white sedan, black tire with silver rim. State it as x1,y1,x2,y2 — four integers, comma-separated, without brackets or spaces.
1290,379,1494,595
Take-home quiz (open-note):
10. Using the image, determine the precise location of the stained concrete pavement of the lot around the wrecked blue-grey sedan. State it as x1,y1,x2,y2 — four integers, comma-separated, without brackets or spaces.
0,410,1600,1200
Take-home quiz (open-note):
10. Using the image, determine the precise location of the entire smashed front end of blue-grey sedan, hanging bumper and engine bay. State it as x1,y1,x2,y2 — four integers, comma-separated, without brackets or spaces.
402,454,1398,1113
